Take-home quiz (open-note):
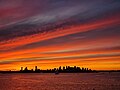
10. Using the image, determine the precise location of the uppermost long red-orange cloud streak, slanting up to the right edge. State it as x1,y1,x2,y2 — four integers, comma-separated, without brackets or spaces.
0,16,120,50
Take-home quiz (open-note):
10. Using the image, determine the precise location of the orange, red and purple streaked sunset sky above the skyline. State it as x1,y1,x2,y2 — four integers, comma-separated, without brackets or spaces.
0,0,120,70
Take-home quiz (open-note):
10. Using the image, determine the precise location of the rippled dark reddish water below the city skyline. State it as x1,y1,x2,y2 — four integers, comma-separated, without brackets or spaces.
0,72,120,90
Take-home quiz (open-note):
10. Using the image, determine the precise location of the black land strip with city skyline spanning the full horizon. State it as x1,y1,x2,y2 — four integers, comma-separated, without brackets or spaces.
0,66,120,74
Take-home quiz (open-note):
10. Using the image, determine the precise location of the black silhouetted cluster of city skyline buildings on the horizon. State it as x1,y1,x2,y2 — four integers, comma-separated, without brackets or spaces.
20,66,92,73
